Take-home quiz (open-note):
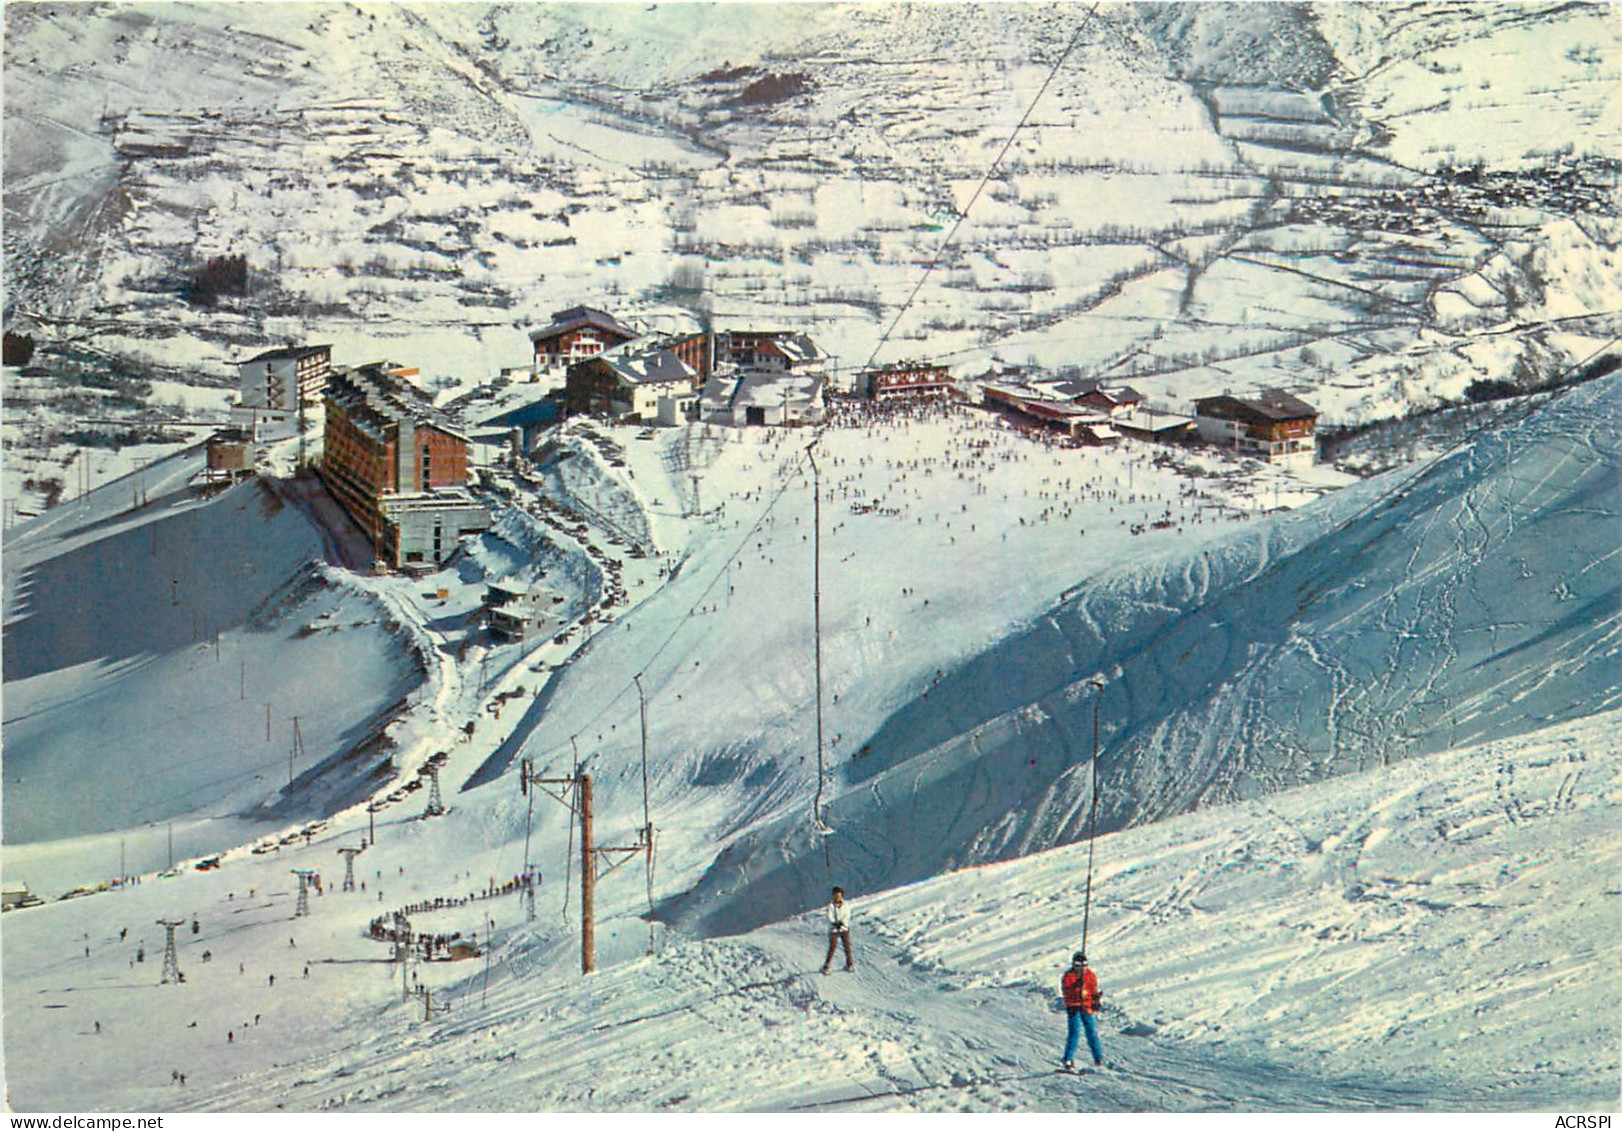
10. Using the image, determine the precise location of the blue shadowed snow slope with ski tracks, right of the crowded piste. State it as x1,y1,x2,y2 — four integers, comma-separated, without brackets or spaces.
672,369,1622,931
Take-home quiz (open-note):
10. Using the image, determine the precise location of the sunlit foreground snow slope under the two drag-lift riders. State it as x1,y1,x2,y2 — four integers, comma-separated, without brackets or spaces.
3,712,1622,1112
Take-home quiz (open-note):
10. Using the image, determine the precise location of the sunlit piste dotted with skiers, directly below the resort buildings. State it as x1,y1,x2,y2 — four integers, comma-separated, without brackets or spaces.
477,409,1346,837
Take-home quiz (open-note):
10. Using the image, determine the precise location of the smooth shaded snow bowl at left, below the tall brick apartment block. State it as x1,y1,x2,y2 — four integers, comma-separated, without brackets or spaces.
3,449,420,894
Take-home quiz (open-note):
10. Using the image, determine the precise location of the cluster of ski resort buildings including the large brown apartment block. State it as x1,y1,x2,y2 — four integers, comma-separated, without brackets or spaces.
203,307,1317,571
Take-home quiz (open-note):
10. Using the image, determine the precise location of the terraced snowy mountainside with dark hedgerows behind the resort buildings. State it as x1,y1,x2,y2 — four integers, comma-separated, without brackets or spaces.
5,3,1622,511
